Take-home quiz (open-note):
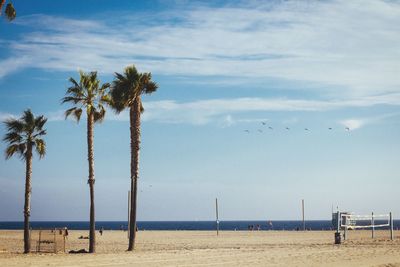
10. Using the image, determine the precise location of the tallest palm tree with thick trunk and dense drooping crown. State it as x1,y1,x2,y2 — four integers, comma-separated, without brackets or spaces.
111,65,158,251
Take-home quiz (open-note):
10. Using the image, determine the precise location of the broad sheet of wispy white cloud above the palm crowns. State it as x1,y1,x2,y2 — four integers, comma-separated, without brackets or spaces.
0,0,400,96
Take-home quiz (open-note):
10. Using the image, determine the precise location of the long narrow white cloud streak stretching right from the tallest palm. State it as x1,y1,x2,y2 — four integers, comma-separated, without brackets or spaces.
139,94,400,127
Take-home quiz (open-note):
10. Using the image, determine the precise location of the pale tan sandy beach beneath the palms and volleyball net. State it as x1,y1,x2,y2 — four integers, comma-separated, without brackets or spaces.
0,230,400,267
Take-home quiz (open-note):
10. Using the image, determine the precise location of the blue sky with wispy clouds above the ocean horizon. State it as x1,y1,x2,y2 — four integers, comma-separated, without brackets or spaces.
0,0,400,221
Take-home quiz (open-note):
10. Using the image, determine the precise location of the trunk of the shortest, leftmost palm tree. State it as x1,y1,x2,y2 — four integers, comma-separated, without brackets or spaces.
24,144,32,253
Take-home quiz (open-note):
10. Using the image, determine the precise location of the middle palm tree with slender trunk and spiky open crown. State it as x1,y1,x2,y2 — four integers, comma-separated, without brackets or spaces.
62,71,110,253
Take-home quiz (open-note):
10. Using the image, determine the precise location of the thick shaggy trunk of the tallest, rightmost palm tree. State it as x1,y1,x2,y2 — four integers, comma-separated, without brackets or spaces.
128,96,141,251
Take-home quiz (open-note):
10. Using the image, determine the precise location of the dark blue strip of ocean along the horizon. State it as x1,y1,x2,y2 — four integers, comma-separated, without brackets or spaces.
0,220,400,231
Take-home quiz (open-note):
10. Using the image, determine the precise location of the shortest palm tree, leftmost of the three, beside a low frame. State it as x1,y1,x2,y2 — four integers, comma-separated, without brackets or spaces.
3,109,47,253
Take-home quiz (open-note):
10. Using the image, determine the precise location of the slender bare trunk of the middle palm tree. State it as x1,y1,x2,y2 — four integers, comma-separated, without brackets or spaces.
87,113,96,253
